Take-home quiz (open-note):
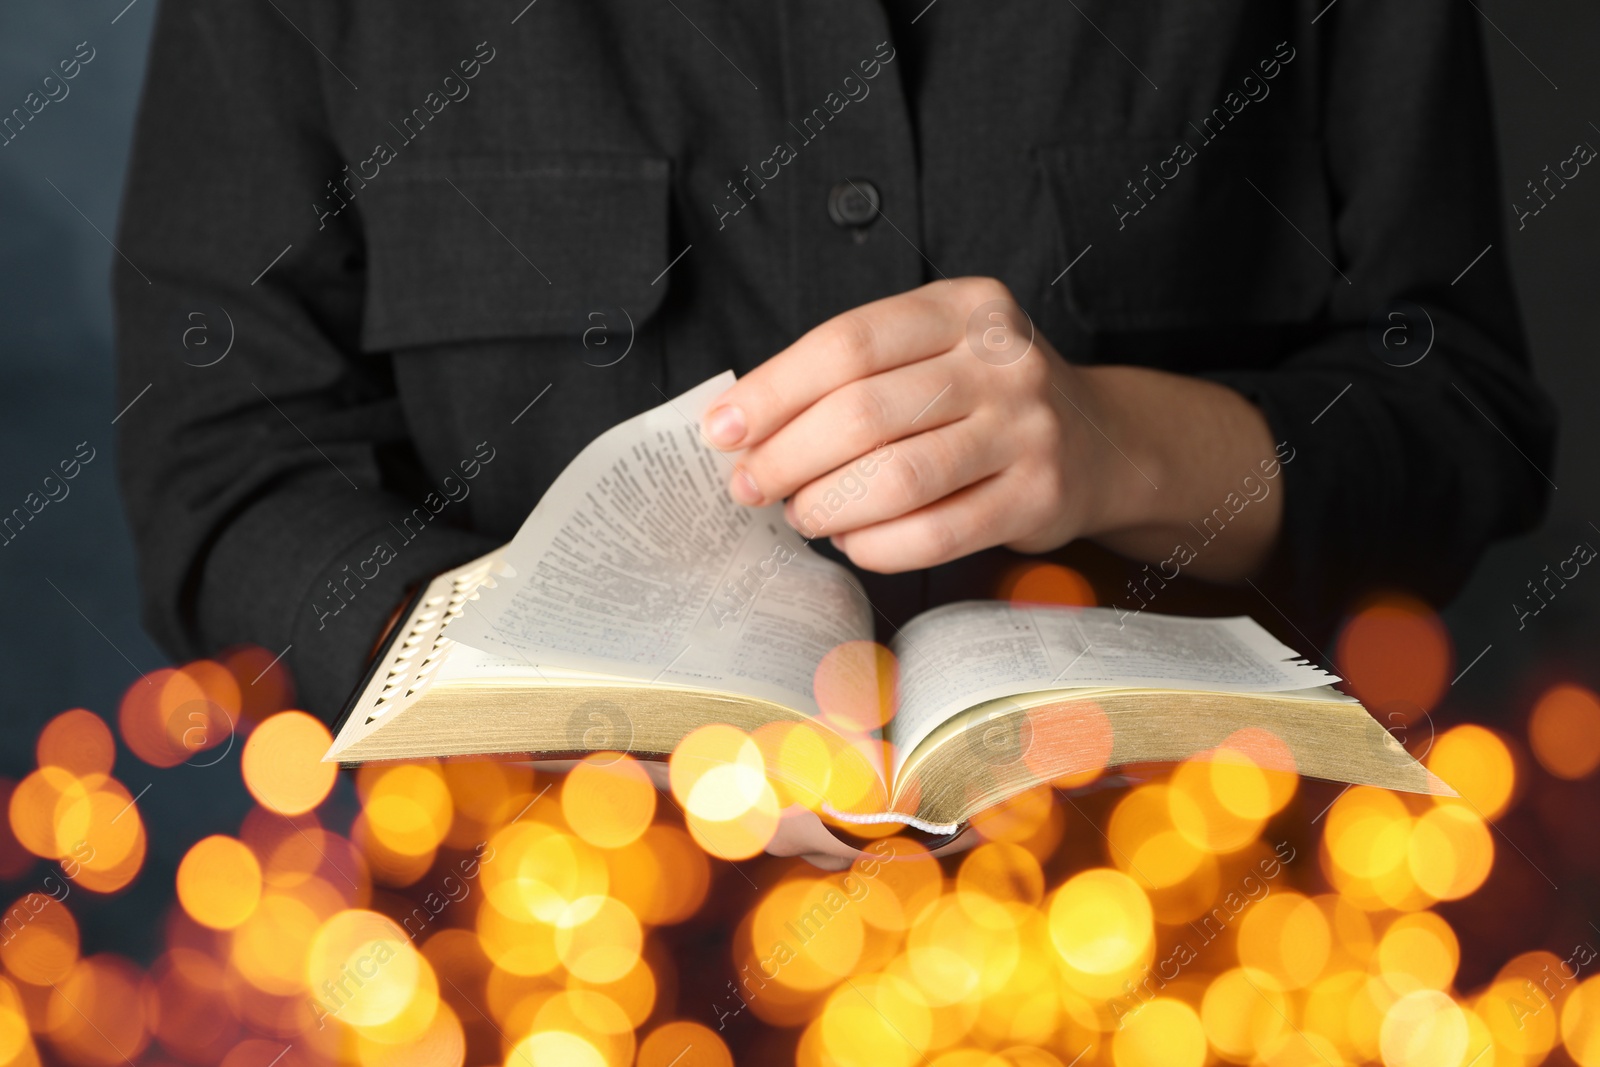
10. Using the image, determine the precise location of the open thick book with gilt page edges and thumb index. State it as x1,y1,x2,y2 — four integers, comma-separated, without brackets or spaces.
325,374,1453,833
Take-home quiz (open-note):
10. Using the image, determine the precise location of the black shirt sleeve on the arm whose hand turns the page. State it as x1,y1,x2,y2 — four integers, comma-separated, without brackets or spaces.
1208,0,1555,629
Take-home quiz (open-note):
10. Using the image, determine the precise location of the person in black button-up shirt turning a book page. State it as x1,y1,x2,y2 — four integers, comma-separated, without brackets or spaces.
115,0,1554,748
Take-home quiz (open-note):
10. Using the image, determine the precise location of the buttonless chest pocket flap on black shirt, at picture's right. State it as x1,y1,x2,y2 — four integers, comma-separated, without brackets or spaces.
1037,134,1342,333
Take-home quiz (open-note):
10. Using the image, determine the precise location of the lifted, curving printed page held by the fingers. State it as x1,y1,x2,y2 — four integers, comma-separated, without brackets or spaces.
450,373,872,715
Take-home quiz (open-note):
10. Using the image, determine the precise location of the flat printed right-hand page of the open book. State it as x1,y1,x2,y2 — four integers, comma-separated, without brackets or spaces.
888,600,1338,774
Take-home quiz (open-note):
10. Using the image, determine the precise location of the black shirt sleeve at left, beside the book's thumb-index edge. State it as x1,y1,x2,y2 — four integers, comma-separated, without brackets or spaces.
114,0,493,718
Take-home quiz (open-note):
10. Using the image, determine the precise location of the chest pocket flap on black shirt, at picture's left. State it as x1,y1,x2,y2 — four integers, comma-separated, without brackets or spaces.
362,155,670,352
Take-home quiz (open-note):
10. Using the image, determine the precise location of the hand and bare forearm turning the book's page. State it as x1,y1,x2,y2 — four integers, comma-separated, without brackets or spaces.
702,278,1280,579
